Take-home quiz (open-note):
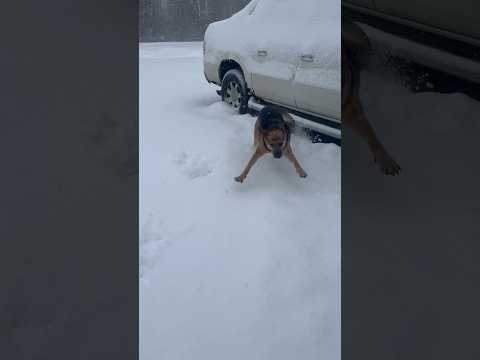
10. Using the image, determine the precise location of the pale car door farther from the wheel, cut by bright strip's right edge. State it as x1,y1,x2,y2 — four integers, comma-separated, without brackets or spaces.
292,3,341,121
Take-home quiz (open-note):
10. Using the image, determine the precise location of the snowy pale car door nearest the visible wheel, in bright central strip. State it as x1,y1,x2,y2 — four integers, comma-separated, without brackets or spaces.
249,0,303,107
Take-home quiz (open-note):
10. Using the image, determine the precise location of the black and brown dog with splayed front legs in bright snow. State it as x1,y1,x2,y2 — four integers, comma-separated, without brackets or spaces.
235,106,307,183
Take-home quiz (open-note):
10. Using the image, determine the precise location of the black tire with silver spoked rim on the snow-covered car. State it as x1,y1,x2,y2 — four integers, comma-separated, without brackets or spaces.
222,69,249,114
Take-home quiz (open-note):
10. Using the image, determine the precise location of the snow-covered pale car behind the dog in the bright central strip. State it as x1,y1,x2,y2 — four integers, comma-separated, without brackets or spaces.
203,0,341,134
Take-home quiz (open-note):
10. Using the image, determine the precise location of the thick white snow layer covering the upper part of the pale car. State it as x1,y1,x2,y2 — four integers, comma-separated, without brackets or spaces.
206,0,341,60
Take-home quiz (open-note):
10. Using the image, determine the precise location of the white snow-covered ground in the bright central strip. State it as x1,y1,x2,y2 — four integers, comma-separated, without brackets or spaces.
139,43,340,360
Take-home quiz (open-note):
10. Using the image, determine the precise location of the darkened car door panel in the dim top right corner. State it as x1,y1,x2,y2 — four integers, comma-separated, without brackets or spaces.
375,0,480,40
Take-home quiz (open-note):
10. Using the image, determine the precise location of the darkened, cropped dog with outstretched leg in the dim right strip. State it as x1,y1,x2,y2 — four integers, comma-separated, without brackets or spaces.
341,17,401,175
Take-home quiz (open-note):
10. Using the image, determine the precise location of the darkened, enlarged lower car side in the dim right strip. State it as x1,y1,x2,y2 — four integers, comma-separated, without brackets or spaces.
342,0,480,82
